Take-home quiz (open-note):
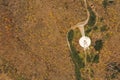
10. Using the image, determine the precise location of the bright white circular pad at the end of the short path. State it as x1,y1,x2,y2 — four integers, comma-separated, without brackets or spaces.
79,36,91,49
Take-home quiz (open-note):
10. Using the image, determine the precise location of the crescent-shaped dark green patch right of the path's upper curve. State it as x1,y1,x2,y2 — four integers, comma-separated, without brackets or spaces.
88,7,96,27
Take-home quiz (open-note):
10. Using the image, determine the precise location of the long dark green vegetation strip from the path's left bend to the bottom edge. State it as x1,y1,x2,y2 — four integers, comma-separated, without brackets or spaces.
67,30,85,80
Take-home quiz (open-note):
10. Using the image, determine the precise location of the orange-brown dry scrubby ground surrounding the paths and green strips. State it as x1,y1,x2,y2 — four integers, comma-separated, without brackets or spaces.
0,0,120,80
